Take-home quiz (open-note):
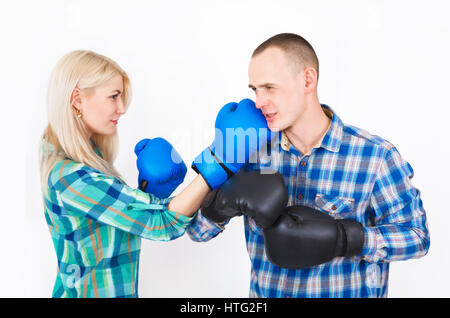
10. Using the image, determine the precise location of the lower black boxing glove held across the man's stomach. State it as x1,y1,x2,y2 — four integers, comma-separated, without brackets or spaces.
263,205,364,269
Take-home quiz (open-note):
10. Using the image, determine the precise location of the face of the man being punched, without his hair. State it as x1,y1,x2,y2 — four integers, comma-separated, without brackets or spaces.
248,47,305,131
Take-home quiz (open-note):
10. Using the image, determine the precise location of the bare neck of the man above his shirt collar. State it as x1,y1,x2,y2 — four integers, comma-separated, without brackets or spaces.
284,101,331,154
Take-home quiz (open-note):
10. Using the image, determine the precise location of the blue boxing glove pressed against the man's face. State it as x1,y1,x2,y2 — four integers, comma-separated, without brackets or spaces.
192,99,273,189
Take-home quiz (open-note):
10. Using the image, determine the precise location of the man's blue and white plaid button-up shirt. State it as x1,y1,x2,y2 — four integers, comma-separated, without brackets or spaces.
187,105,430,298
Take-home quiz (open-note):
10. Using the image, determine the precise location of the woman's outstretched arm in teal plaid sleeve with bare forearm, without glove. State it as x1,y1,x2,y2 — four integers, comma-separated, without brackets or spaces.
46,159,203,241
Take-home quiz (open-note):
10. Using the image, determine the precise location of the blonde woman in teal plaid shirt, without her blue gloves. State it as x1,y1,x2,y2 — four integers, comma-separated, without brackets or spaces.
40,51,209,297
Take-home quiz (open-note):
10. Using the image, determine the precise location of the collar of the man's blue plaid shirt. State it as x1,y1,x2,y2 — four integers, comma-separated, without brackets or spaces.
279,104,344,152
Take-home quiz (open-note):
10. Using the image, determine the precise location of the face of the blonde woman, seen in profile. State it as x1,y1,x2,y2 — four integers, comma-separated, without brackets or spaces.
72,75,125,137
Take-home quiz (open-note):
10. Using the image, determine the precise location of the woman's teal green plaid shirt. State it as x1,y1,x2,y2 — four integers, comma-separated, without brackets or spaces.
44,150,192,297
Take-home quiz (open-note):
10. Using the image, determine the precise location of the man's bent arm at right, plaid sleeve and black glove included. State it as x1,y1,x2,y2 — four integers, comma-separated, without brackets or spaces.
264,148,430,268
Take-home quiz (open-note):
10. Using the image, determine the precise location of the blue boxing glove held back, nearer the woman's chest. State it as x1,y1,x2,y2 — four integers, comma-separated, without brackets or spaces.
134,137,187,198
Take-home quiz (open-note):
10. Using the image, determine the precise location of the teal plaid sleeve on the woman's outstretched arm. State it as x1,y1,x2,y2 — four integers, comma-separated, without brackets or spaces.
53,159,192,241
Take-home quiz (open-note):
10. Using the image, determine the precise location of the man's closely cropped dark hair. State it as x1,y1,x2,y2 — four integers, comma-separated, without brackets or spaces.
252,33,319,78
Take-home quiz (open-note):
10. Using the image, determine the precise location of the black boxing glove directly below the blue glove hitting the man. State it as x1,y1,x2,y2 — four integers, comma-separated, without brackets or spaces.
201,170,288,228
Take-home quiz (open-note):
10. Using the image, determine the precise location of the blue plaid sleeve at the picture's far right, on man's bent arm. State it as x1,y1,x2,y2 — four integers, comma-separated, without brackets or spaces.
362,147,430,263
